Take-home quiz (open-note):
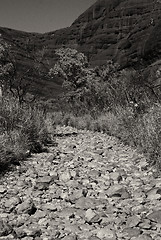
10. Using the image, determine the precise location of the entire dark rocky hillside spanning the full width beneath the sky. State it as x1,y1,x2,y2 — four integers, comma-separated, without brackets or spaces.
0,0,161,97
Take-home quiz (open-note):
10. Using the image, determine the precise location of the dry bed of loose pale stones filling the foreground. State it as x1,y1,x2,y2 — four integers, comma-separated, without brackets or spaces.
0,127,161,240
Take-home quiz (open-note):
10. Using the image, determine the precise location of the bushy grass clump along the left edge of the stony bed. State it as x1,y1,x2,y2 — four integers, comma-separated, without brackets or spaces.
0,94,54,171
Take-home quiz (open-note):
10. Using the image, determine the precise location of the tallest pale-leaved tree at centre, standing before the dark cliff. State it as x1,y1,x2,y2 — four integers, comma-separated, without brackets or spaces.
49,48,100,98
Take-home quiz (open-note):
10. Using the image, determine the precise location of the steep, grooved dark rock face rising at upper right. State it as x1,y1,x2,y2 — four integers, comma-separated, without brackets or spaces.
40,0,161,66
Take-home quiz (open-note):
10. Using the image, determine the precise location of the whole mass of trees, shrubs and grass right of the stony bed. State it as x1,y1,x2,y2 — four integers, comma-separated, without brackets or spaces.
50,49,161,169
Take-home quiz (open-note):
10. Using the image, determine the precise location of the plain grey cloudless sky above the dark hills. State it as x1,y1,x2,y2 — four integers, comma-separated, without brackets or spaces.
0,0,96,33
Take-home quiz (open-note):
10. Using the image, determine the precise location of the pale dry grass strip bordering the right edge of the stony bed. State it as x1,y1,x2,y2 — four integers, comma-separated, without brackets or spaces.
53,104,161,169
